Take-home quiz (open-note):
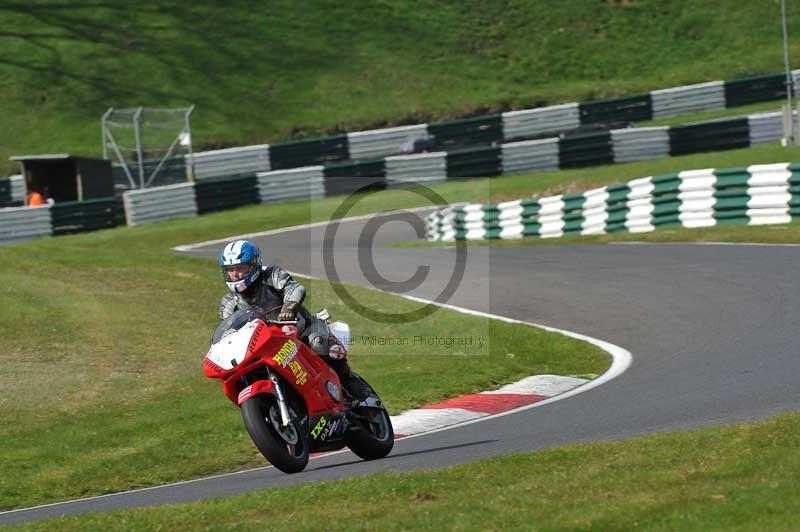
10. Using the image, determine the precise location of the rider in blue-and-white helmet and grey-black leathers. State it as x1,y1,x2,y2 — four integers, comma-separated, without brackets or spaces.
219,240,369,401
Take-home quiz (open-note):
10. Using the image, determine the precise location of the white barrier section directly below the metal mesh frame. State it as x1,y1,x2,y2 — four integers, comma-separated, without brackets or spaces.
123,183,197,225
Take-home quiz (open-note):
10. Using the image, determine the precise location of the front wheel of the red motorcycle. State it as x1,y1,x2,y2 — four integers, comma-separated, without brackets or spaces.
241,395,309,473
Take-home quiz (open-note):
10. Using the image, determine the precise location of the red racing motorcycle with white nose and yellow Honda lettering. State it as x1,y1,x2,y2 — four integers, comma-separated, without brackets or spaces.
204,307,394,473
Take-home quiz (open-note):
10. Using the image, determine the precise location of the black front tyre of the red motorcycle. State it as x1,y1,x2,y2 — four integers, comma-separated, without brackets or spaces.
241,395,309,473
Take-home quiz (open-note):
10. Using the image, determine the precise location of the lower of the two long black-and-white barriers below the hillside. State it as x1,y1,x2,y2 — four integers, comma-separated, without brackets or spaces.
0,108,783,242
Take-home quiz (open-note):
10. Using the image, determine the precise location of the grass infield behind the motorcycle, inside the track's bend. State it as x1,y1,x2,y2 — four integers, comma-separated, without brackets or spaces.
0,189,609,509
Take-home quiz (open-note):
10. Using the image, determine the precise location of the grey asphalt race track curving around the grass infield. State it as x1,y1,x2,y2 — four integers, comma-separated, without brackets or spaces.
0,209,800,524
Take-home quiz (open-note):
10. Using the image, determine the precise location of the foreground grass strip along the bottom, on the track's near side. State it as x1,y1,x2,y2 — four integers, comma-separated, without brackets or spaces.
7,414,800,531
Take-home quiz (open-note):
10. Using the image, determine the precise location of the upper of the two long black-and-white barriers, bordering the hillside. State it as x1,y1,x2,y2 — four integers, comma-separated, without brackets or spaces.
187,70,800,179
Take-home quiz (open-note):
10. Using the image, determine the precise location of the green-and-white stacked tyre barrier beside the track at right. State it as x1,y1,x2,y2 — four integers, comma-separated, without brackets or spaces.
426,163,800,241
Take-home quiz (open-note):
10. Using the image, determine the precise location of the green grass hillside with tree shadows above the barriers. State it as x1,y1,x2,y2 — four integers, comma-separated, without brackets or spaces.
0,0,800,173
